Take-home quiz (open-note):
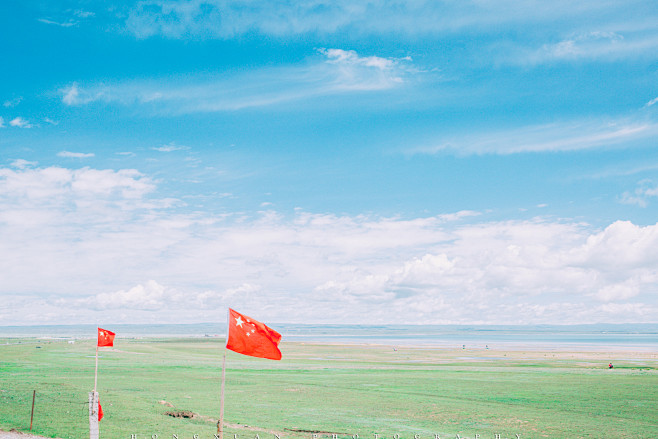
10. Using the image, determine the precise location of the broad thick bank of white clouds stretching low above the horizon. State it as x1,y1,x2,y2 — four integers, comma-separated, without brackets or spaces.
0,166,658,323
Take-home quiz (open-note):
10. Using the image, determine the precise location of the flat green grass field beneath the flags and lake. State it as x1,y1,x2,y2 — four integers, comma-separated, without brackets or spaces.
0,338,658,439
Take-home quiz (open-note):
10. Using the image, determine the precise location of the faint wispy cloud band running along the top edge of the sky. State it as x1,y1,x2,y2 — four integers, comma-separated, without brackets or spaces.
126,0,655,43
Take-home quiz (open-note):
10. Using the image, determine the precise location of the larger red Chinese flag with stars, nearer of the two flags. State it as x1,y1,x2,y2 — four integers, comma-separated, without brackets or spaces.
226,308,281,360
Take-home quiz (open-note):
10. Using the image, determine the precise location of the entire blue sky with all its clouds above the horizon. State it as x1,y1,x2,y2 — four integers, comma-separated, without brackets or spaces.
0,0,658,324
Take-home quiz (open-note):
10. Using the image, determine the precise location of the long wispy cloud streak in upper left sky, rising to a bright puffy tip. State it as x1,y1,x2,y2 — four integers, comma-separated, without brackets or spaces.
60,49,417,113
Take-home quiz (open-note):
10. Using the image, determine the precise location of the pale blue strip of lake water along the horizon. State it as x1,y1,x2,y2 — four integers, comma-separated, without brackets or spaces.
0,323,658,352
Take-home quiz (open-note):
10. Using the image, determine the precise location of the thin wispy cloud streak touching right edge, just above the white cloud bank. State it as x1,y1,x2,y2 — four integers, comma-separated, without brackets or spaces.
406,119,658,155
